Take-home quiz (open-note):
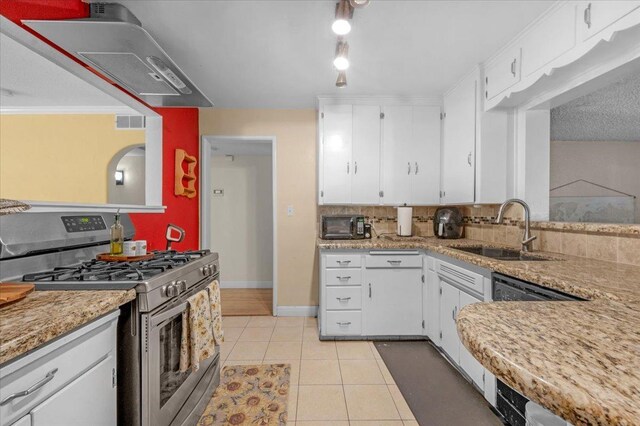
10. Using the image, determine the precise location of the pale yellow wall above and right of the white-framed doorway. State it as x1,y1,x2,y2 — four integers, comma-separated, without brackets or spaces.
200,109,318,306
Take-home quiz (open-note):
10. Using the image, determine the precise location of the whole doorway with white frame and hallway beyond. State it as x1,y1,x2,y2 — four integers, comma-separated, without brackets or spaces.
200,136,277,316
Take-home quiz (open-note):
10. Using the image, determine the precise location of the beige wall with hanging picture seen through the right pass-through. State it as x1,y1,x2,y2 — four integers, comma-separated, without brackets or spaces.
550,141,640,223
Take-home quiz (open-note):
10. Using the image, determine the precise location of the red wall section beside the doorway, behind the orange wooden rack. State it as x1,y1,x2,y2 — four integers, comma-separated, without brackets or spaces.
131,108,200,250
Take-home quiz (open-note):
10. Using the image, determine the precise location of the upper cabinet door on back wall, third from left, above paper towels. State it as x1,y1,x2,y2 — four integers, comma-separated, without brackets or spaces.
382,106,414,205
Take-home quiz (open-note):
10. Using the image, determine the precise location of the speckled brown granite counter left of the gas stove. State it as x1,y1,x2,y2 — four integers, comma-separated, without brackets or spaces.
0,290,136,364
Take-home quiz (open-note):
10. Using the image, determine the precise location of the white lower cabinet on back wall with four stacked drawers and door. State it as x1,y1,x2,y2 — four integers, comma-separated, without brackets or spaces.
318,250,424,338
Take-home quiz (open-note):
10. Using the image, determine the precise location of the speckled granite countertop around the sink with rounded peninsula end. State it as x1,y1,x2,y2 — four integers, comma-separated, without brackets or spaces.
318,237,640,425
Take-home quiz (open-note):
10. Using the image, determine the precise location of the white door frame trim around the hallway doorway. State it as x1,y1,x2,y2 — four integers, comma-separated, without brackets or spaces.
200,135,278,316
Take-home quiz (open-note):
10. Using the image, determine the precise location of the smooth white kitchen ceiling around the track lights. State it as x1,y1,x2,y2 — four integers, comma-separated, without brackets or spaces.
114,0,553,108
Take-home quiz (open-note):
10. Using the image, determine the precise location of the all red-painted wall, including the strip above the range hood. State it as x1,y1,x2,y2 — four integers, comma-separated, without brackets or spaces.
0,0,200,250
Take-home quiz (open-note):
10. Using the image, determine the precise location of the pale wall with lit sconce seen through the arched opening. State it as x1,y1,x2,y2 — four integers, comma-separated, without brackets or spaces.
107,153,145,205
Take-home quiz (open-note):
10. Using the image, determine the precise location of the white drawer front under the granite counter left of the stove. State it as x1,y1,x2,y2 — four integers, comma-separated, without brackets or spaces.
0,312,119,424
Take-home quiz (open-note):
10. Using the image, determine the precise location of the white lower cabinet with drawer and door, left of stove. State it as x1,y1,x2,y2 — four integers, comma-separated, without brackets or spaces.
0,311,119,426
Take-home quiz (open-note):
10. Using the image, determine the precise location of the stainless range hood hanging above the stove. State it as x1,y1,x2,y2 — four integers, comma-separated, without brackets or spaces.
22,3,213,107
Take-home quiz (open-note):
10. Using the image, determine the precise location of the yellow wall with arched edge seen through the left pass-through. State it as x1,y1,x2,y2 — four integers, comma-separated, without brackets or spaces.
0,114,145,203
